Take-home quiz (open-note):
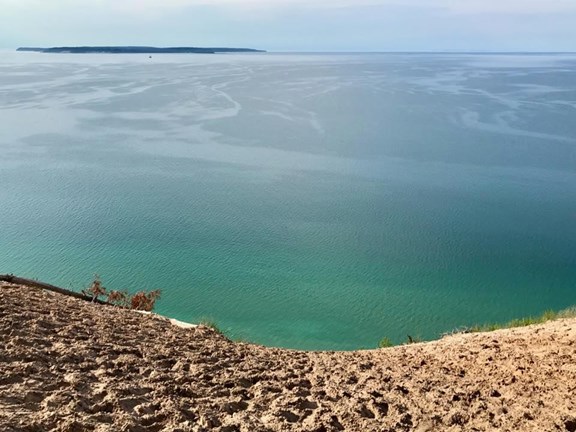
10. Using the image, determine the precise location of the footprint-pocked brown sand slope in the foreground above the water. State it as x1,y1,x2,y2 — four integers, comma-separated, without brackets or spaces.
0,284,576,432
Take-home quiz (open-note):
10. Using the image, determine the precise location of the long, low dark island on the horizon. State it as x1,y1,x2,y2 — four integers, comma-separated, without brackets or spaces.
16,46,266,54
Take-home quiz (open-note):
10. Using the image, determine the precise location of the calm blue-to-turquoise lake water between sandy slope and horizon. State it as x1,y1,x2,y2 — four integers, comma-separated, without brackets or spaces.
0,53,576,349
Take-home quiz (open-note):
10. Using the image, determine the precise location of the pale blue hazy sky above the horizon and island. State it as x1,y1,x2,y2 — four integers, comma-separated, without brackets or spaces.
0,0,576,51
